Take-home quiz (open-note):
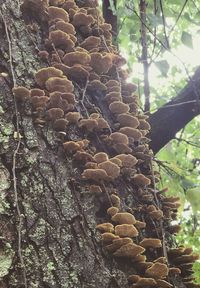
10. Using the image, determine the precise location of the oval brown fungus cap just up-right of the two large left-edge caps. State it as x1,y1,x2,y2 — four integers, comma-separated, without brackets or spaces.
63,51,91,67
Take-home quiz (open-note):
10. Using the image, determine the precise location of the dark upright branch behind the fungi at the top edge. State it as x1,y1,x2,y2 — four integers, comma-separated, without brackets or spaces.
103,0,118,39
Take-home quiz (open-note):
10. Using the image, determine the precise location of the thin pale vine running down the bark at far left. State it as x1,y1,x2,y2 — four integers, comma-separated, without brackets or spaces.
0,11,28,288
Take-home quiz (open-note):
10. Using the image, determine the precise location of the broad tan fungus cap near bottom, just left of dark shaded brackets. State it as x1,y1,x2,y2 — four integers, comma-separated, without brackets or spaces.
145,263,169,279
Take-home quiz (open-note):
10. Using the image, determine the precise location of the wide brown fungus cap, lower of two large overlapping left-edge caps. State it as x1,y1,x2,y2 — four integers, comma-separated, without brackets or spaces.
45,77,74,93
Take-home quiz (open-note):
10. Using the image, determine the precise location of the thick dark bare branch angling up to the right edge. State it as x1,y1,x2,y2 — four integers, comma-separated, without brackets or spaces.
148,68,200,154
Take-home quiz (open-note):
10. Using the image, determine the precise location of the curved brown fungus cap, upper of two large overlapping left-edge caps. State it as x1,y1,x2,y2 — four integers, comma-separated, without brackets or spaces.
35,67,63,87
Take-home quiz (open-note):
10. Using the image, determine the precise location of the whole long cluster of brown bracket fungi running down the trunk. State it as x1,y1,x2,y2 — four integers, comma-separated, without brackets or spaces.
16,0,197,288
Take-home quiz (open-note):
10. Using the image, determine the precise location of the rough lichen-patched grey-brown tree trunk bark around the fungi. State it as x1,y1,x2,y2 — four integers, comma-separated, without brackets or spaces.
0,0,197,288
